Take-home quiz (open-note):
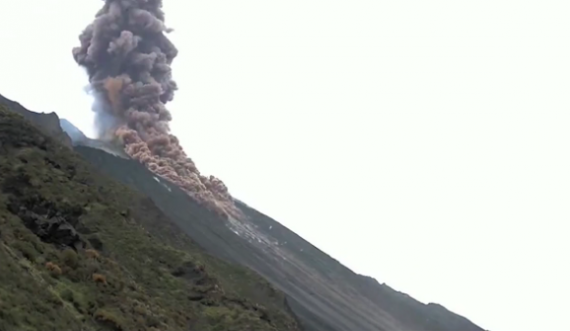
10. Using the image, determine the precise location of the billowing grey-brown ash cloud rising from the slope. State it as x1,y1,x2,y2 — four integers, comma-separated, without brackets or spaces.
73,0,236,220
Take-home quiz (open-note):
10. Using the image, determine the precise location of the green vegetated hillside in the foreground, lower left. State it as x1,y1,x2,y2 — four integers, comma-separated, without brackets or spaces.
0,105,298,331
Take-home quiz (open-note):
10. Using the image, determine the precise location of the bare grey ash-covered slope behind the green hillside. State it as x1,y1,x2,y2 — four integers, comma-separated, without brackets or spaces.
0,93,483,331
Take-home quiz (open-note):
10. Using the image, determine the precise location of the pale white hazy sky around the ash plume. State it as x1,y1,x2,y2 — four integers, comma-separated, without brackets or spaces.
0,0,570,331
